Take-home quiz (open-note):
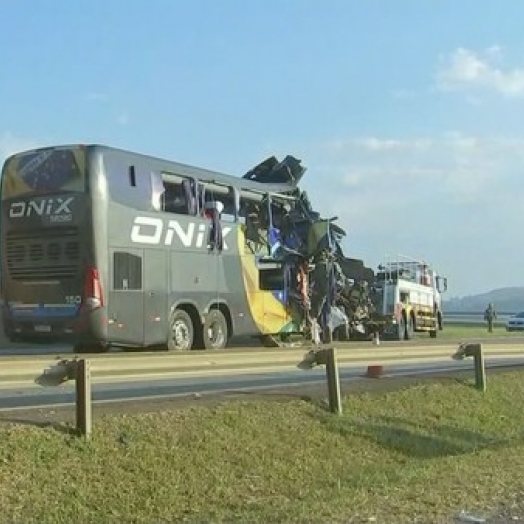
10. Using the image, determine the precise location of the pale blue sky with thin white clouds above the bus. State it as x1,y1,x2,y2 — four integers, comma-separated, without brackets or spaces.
0,0,524,296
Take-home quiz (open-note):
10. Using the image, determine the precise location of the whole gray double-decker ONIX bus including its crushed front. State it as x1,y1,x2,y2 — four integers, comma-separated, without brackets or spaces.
0,145,373,352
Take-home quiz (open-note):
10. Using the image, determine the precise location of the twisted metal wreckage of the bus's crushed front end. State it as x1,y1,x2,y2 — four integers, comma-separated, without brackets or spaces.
239,155,381,345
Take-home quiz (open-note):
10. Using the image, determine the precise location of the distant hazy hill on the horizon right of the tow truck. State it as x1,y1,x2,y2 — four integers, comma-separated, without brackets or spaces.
443,287,524,313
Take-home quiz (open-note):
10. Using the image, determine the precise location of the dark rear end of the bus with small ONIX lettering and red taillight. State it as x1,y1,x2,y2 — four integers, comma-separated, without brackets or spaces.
0,146,103,341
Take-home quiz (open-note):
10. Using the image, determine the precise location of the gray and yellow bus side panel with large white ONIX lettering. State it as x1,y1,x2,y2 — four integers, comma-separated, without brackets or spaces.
96,146,296,344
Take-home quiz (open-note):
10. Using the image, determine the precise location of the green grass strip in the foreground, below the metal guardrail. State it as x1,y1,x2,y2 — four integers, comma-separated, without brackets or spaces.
0,372,524,523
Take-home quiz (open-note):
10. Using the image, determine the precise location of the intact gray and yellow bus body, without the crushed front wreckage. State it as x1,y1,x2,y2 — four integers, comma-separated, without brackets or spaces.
0,145,296,350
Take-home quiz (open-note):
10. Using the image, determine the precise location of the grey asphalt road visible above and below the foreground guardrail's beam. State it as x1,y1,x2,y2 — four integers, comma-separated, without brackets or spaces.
0,316,524,411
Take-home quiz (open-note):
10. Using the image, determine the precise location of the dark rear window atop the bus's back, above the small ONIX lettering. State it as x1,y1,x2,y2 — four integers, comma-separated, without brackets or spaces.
2,147,86,200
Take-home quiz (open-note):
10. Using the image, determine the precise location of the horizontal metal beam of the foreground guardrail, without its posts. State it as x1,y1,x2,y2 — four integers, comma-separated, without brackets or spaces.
0,342,524,389
